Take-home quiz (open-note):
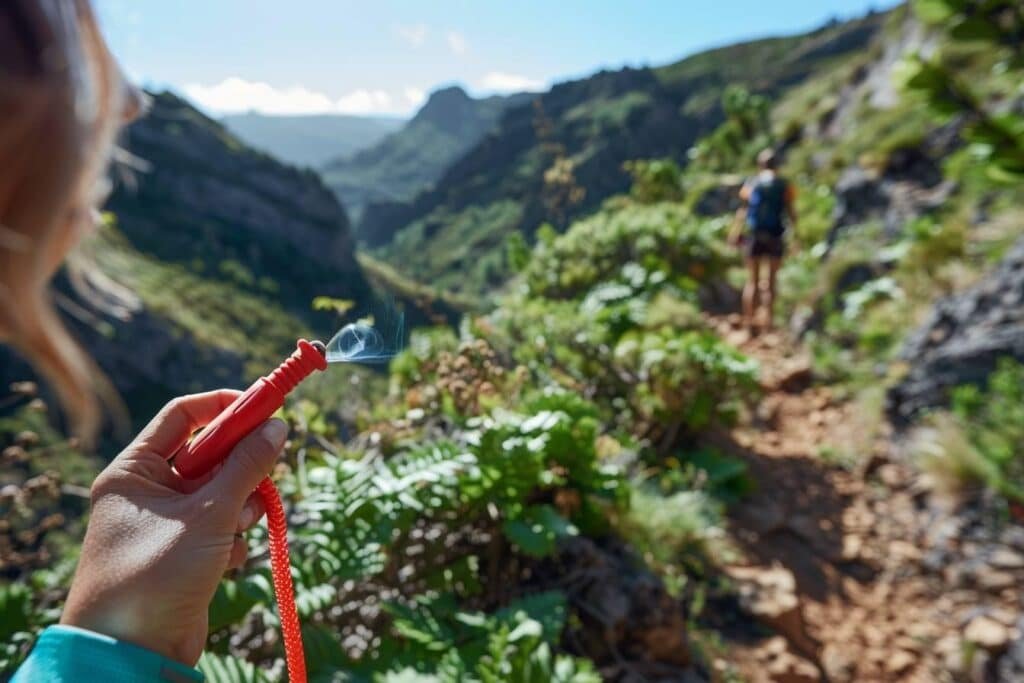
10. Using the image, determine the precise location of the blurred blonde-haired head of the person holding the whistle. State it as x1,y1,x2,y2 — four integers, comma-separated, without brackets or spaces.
0,0,140,438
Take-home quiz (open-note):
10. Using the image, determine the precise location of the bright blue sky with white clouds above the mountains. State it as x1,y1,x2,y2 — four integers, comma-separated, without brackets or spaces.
94,0,895,116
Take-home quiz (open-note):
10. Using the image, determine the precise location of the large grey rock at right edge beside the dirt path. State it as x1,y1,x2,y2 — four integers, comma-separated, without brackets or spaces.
887,240,1024,427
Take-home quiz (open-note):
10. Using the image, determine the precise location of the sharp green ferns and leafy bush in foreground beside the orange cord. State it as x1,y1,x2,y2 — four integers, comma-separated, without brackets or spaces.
204,392,628,681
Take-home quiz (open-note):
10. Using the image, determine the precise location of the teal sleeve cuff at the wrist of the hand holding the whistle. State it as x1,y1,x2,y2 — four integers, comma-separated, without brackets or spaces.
11,626,203,683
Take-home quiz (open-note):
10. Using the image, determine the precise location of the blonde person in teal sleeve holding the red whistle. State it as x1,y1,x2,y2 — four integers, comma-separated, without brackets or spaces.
0,0,288,683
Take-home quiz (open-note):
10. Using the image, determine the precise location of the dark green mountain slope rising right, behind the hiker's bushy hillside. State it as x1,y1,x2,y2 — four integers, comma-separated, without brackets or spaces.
368,13,886,296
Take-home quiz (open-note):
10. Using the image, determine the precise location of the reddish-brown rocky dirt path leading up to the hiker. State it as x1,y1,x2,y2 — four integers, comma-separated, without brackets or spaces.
713,316,1024,682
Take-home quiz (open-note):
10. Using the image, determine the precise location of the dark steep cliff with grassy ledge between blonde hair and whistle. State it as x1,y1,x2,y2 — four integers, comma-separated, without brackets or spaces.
0,93,370,428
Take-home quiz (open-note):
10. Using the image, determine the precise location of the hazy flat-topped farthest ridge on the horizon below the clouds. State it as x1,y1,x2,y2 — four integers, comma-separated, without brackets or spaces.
220,113,406,167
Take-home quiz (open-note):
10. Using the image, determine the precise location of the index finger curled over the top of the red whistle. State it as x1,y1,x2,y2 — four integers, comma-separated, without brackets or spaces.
132,389,242,459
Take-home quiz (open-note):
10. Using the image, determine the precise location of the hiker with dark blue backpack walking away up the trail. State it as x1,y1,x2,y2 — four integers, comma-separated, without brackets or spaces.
732,148,797,335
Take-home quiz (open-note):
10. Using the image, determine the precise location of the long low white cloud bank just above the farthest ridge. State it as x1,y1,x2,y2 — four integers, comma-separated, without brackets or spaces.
182,76,425,115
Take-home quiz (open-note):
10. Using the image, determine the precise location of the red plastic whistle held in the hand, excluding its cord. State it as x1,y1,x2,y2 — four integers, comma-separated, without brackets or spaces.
174,339,327,479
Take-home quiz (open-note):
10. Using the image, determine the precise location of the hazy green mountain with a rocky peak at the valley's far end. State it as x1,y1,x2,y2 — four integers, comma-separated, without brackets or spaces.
323,86,530,227
